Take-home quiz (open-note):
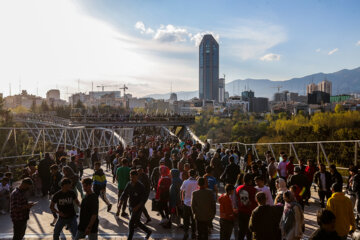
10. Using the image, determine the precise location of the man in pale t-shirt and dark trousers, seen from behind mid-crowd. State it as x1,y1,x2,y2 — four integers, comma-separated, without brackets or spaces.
180,169,199,240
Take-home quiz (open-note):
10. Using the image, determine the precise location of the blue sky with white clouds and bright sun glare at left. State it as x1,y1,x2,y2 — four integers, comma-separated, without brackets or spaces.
0,0,360,97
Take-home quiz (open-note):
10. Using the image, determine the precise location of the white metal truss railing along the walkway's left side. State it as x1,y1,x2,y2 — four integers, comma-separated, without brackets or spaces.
0,127,133,164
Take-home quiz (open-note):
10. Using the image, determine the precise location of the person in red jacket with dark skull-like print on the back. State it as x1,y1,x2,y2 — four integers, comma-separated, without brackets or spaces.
236,174,257,240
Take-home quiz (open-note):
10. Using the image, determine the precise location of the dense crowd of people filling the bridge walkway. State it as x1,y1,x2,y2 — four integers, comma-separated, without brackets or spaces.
0,134,360,240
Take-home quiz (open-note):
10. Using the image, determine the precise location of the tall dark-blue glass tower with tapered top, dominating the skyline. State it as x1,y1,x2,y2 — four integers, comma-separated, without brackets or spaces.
199,34,219,102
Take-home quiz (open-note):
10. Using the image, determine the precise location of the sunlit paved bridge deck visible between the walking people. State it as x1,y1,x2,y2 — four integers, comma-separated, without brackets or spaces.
0,169,334,240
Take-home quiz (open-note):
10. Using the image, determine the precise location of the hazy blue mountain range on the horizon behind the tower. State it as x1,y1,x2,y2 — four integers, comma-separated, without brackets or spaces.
147,67,360,100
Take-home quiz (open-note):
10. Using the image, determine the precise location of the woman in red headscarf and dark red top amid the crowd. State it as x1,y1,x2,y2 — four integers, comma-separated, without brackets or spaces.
155,165,171,228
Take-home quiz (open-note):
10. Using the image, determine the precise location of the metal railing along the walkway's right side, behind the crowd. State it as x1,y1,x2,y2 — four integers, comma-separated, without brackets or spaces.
212,140,360,166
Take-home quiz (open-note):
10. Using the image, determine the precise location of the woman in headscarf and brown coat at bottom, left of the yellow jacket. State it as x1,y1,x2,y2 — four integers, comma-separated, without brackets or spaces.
280,191,304,240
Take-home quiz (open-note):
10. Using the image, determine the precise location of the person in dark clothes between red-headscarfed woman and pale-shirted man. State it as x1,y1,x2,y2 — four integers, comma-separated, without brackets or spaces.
169,169,182,227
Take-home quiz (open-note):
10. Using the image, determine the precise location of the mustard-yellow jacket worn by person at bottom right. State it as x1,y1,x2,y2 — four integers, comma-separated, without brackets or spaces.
326,192,355,237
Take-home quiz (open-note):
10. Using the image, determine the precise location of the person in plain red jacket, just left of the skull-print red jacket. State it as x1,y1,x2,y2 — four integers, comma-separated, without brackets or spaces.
219,184,235,240
